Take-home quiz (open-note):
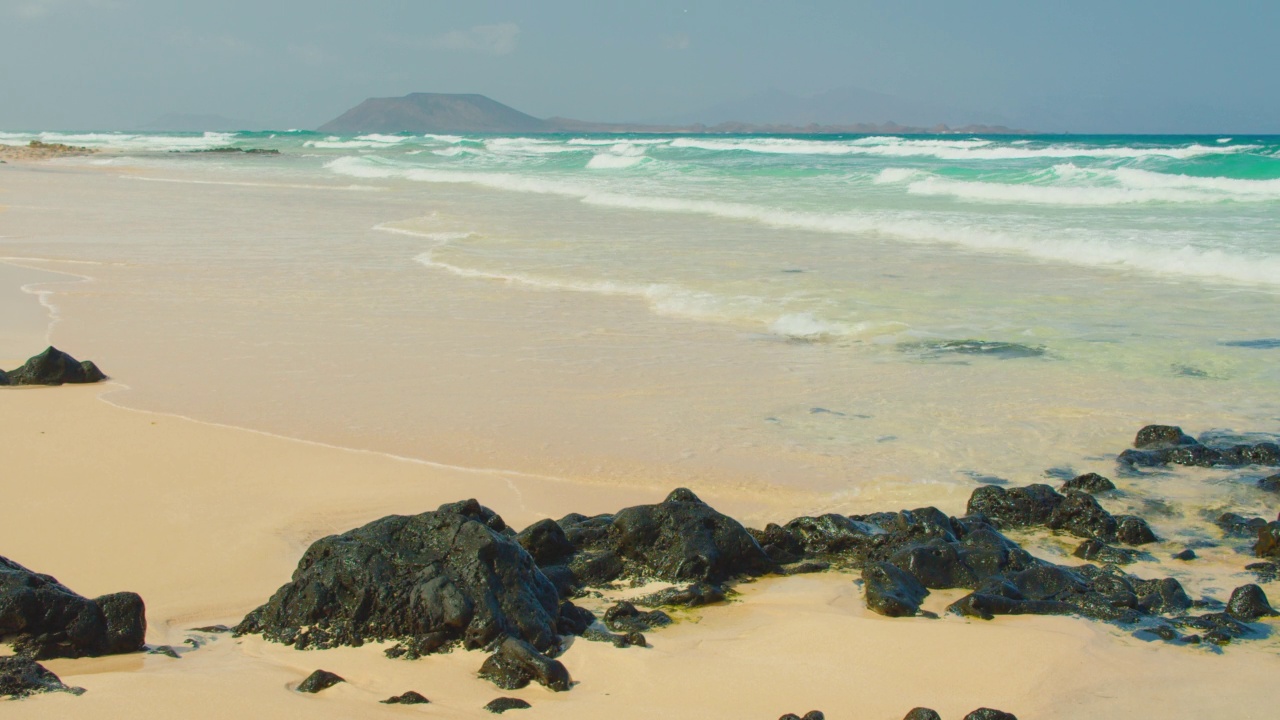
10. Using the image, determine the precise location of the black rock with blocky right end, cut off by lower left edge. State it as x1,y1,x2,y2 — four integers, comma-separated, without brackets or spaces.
0,557,147,660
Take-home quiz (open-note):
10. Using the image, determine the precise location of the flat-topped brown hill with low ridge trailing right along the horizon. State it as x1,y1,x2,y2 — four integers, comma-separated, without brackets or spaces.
317,92,1027,135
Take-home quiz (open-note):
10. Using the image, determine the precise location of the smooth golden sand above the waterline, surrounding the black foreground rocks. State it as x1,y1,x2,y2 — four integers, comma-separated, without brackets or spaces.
0,169,1280,720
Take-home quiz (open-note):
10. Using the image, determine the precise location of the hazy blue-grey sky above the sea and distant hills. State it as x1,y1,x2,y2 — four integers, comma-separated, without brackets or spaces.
0,0,1280,132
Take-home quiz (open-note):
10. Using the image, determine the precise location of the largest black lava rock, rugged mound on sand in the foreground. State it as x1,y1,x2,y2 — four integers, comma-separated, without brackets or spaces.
236,500,559,653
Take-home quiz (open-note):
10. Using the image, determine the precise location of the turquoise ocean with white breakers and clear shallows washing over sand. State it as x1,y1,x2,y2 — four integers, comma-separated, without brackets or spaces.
0,131,1280,523
